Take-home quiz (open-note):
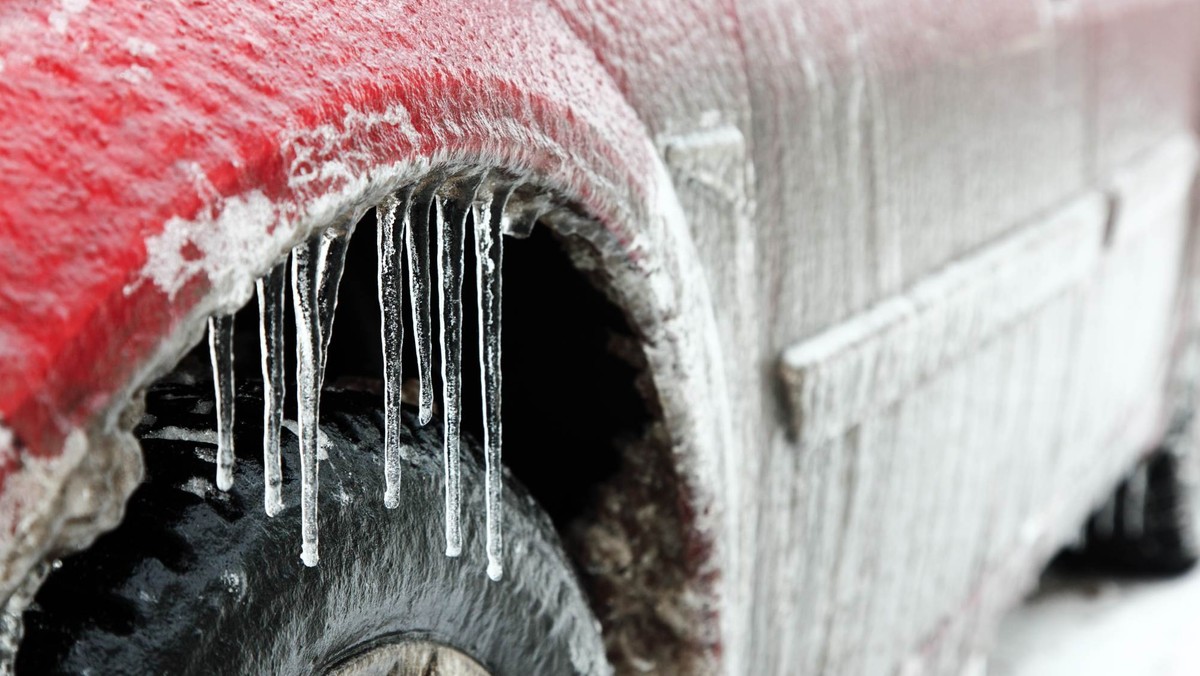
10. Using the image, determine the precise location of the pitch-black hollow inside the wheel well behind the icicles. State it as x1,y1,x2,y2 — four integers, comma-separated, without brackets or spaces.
168,210,649,532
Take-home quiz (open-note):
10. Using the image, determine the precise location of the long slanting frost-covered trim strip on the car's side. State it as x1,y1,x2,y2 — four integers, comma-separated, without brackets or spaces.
781,195,1106,447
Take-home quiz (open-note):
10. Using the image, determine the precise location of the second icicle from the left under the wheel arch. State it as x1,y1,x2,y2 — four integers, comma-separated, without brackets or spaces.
257,261,288,516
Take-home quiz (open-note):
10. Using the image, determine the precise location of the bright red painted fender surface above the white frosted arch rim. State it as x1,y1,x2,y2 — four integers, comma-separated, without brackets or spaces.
0,0,650,465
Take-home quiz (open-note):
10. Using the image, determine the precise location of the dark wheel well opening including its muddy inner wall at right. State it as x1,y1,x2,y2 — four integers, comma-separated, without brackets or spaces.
153,200,707,670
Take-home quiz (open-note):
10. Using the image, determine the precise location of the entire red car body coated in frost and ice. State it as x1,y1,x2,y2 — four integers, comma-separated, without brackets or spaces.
0,0,1200,674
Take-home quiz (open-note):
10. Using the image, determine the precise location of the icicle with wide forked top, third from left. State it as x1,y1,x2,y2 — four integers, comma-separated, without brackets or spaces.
292,214,358,566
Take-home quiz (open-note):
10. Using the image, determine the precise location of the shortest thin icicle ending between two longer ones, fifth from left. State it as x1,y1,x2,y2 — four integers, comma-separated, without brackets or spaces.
408,183,442,425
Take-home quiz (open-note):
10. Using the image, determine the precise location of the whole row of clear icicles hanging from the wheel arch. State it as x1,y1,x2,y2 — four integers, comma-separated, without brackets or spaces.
209,175,512,580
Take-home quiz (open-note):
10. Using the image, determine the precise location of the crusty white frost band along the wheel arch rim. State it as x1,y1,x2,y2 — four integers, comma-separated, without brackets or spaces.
127,88,724,624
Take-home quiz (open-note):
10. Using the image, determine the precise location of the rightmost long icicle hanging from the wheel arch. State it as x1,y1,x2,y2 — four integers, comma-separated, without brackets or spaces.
475,181,512,580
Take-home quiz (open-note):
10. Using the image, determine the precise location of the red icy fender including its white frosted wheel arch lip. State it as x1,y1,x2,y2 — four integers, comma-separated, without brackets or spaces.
0,1,728,656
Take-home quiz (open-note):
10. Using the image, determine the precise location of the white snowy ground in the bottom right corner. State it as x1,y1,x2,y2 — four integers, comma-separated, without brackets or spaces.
989,570,1200,676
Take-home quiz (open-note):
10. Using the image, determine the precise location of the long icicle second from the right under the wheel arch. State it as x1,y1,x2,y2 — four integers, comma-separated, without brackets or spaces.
438,177,482,556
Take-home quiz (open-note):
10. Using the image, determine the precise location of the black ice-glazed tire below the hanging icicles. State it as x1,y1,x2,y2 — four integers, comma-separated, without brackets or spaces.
17,384,608,676
